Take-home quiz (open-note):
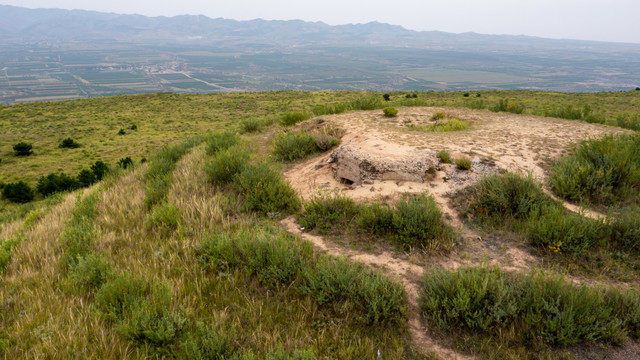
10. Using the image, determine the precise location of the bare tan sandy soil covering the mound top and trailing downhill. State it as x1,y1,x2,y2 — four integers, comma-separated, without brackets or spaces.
282,108,625,359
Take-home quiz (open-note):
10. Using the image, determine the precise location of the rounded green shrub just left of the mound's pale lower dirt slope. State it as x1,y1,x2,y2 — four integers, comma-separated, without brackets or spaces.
233,162,300,214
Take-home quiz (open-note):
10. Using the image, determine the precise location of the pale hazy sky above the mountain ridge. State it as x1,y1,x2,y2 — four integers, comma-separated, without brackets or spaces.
0,0,640,43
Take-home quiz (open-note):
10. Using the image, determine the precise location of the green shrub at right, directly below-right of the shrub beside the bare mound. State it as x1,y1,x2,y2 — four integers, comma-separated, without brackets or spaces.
527,206,609,256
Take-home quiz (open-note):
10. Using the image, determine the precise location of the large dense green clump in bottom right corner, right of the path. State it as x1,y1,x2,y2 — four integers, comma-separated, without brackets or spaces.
420,267,640,349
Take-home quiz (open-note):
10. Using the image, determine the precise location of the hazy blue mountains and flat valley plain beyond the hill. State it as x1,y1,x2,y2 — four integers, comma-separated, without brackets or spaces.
0,5,640,102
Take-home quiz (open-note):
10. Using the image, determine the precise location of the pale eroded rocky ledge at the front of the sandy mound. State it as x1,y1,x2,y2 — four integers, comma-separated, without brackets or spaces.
327,143,438,185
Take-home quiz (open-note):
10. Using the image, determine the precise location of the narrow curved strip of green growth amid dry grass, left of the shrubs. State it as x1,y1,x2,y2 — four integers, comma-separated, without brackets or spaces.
144,138,201,209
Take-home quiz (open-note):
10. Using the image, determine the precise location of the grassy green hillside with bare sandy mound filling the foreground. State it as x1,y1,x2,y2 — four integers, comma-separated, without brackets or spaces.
0,91,640,359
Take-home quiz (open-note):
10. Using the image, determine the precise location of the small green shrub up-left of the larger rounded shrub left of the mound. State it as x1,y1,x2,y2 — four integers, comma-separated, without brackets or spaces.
204,145,249,184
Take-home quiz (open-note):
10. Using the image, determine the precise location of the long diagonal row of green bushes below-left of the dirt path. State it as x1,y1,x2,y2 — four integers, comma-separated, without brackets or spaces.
198,231,407,326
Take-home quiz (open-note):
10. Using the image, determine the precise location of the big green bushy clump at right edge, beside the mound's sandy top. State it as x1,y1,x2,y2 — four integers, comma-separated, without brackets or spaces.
551,134,640,205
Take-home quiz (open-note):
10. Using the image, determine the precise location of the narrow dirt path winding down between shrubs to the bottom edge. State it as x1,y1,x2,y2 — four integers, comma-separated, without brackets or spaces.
280,216,475,360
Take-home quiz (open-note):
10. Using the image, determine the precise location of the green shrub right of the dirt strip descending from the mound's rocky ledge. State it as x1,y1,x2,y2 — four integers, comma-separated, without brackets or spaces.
469,173,553,222
